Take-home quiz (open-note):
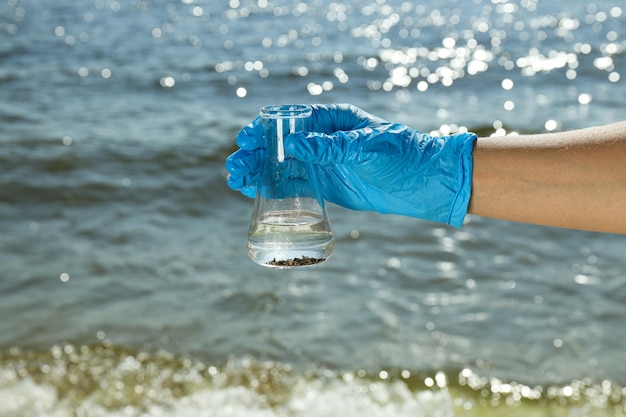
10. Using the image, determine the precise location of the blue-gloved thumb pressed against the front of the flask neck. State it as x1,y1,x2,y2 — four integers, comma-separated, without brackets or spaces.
285,131,359,165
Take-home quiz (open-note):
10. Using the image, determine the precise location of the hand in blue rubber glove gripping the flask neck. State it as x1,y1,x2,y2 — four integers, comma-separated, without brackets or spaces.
226,105,476,227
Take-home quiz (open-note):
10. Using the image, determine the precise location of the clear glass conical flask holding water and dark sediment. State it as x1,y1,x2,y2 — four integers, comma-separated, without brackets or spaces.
248,104,334,268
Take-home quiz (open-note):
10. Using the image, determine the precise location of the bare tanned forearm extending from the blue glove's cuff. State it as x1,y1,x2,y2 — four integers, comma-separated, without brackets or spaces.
469,122,626,233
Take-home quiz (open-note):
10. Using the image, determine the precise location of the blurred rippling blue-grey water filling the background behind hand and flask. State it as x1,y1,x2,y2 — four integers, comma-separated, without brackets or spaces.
0,0,626,417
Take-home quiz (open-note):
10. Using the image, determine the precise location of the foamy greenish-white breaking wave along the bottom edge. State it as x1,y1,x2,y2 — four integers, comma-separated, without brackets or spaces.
0,340,626,417
